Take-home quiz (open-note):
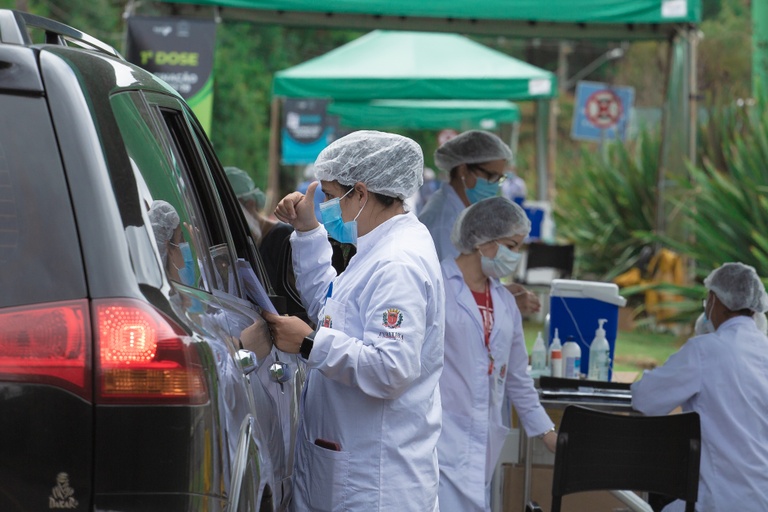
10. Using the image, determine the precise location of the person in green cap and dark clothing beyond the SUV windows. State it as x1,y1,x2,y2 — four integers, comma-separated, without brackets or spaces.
224,167,307,320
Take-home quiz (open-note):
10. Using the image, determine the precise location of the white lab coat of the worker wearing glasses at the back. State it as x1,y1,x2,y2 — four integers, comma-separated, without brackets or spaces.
419,183,466,261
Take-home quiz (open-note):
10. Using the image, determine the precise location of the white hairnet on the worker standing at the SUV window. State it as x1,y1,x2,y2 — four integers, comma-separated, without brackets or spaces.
315,130,424,200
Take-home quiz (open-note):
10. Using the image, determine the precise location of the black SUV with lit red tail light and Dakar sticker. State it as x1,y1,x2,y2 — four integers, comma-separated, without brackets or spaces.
0,10,304,512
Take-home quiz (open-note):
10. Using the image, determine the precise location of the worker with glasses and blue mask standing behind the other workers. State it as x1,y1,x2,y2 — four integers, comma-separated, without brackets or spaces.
419,130,541,314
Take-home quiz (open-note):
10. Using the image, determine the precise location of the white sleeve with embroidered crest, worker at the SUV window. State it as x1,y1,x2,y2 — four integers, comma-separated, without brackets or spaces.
308,262,439,399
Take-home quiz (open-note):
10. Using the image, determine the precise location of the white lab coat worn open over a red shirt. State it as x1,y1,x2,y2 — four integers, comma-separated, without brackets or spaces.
437,260,554,512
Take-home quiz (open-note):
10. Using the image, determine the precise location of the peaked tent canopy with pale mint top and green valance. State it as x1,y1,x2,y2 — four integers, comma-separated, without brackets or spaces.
272,30,557,101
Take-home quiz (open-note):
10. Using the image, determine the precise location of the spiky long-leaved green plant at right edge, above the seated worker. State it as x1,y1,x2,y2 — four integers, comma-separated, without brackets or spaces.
664,92,768,276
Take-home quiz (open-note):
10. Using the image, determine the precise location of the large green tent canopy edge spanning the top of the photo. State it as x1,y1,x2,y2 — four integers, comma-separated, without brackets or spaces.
154,0,702,40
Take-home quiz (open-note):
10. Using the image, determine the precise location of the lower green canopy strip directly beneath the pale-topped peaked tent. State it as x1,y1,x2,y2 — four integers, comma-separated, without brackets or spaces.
328,100,520,131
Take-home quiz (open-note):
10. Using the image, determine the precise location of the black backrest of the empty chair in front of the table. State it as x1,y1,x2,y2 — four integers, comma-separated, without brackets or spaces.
552,405,701,512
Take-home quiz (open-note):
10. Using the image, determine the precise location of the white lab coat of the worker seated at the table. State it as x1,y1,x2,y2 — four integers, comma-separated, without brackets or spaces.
632,316,768,512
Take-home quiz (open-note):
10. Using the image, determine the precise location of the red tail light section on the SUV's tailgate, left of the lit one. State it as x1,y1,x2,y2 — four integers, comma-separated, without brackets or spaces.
0,299,91,401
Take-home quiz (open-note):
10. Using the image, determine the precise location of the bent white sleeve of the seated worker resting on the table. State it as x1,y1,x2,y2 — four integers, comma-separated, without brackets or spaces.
632,341,701,415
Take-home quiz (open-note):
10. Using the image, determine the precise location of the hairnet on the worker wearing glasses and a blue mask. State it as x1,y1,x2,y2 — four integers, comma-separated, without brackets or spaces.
435,130,512,171
